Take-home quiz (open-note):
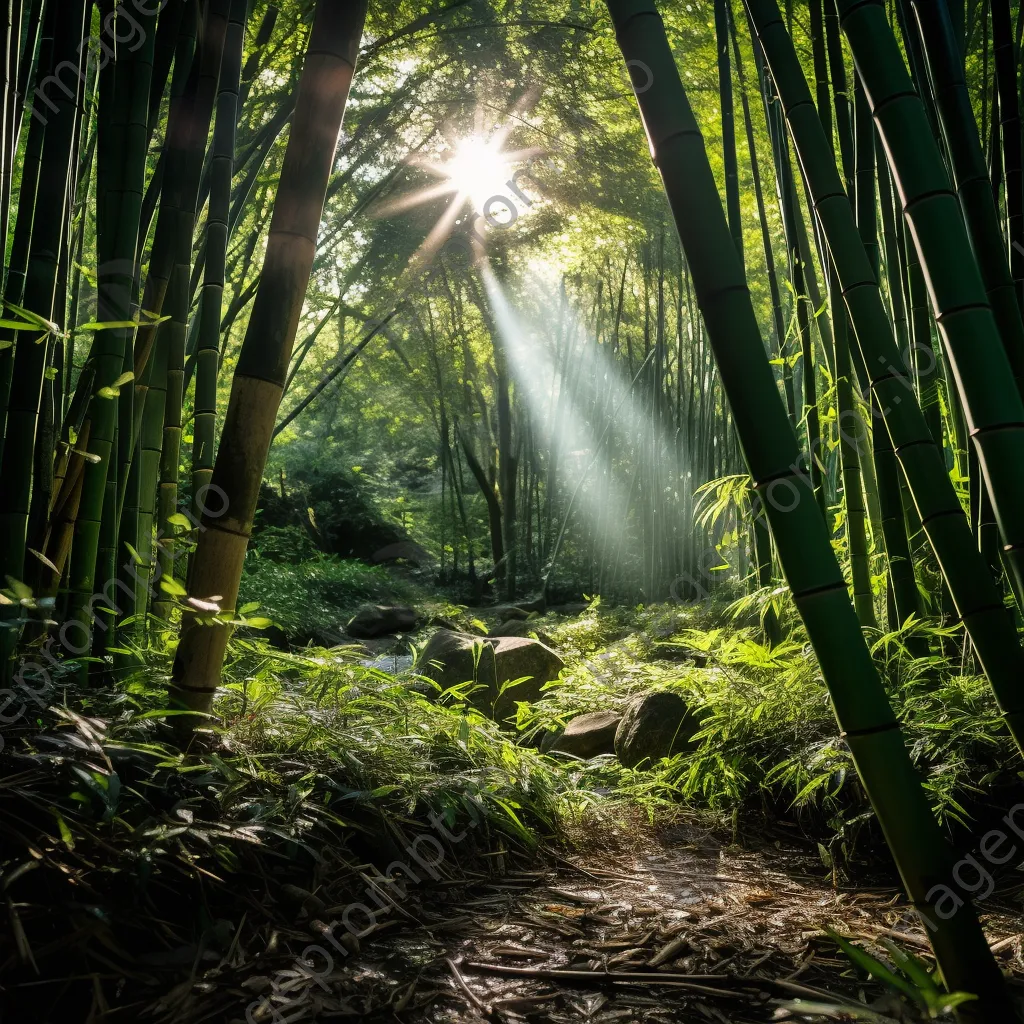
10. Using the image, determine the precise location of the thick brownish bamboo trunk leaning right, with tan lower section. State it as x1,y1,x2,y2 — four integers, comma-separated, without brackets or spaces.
171,0,367,727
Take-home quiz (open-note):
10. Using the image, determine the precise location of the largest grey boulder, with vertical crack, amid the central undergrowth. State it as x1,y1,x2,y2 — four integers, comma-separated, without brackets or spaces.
419,630,563,722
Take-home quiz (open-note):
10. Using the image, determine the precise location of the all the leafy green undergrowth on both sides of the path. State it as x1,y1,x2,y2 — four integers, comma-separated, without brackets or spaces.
0,598,1019,1021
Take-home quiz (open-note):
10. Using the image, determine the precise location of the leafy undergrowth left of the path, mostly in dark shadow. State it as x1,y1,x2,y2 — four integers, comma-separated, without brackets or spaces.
0,641,558,1022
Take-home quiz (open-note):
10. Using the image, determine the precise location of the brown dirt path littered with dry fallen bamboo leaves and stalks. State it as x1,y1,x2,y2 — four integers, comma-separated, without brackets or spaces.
226,825,1024,1024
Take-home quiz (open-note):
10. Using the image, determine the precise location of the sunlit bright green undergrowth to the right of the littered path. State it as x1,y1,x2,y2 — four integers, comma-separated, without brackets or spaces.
518,602,1020,867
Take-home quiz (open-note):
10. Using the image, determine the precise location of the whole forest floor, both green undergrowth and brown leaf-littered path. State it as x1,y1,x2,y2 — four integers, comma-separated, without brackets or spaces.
0,581,1024,1024
